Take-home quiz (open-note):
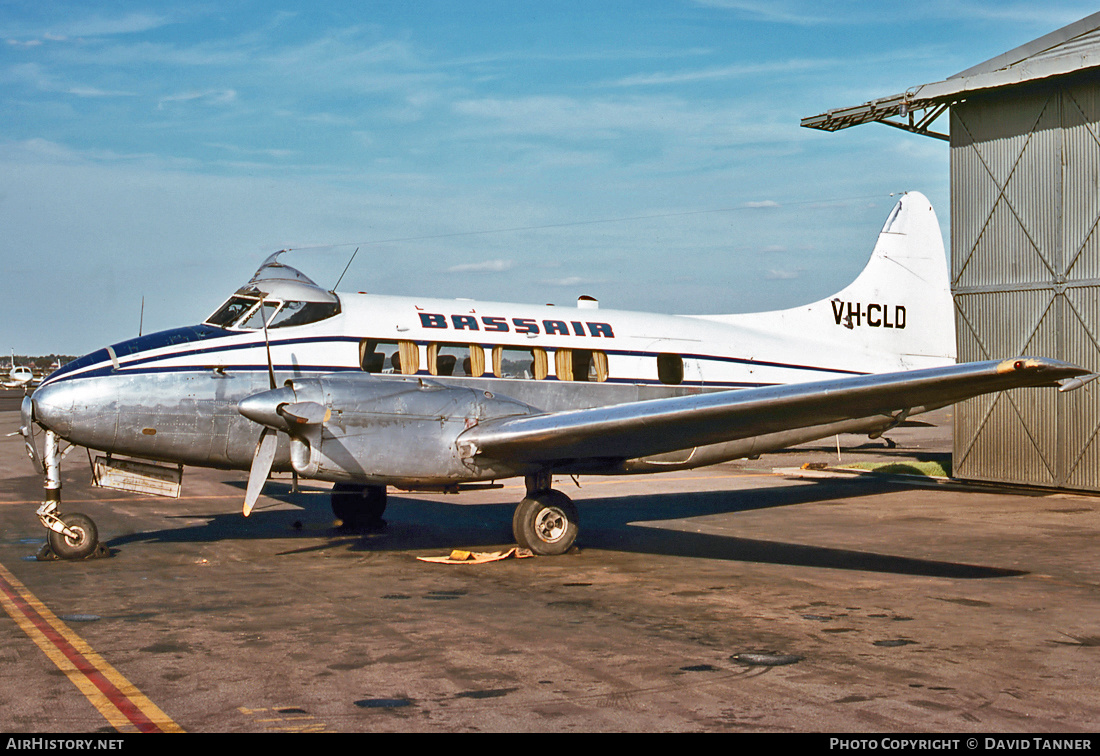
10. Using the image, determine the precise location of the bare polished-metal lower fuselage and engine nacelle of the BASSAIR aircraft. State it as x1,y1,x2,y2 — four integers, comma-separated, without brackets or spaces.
24,370,892,487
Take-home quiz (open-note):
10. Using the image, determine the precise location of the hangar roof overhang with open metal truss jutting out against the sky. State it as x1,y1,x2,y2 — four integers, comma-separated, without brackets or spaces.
802,13,1100,140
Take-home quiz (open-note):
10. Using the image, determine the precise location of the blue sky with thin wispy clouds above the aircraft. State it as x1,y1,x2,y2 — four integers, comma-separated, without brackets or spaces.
0,0,1097,354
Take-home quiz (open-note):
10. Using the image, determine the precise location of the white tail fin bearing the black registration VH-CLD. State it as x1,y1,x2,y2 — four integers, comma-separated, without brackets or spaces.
706,191,955,372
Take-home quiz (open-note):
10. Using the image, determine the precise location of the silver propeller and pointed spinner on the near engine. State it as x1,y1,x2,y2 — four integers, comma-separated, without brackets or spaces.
237,386,332,517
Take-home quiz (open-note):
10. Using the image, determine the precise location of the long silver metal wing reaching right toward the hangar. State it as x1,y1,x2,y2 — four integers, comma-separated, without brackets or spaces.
458,358,1089,462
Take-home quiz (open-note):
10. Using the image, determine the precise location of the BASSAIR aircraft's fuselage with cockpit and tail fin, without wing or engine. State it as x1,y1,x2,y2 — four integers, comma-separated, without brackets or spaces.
35,194,955,481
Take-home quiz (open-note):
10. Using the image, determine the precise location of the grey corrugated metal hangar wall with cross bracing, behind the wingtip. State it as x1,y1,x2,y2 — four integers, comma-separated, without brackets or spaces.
950,75,1100,490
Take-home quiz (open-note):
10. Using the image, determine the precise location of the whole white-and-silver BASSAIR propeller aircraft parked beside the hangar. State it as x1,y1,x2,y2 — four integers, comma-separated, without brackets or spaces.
22,193,1087,558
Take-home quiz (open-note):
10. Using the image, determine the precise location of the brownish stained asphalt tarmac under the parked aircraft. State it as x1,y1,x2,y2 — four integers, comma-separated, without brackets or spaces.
0,396,1100,734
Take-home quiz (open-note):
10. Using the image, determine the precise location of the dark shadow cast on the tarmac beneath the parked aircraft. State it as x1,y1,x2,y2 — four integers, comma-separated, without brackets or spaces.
107,479,1026,579
